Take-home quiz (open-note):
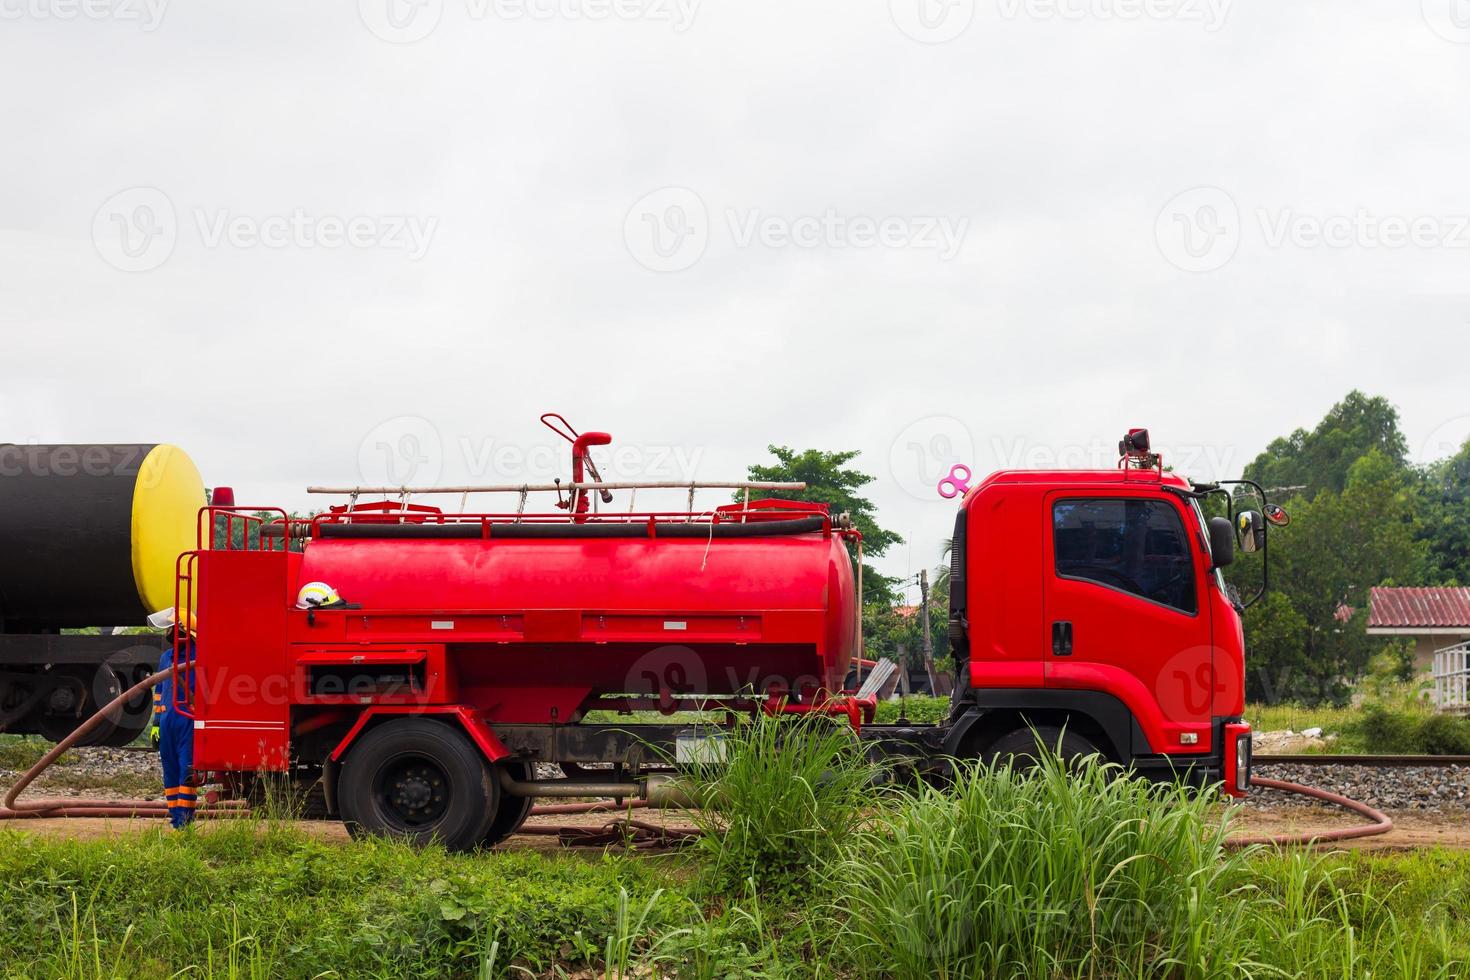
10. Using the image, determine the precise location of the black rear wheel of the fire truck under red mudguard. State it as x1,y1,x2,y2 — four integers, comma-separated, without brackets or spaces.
338,718,500,851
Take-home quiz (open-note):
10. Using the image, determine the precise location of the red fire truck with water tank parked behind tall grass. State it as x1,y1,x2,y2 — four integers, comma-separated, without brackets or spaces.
175,430,1285,849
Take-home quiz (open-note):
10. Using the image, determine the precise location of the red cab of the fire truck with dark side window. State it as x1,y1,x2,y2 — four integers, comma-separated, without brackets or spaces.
945,457,1250,793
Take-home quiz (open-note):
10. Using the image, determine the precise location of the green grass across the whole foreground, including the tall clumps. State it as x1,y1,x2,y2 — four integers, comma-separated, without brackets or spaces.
0,718,1470,980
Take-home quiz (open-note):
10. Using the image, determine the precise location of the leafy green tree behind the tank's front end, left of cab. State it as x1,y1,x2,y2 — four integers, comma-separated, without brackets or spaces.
736,445,904,605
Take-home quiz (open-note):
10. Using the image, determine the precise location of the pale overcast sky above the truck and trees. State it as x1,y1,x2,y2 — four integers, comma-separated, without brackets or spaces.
0,0,1470,593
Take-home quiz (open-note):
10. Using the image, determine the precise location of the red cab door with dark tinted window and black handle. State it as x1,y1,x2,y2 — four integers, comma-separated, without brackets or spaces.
1042,488,1214,752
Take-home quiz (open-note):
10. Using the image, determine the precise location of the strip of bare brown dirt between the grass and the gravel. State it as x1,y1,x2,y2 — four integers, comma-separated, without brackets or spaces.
9,807,1470,851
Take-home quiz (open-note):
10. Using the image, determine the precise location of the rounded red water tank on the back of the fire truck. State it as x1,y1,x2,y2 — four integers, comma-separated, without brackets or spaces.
293,504,856,723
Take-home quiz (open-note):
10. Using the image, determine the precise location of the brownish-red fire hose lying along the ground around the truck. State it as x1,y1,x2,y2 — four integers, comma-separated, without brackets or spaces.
0,669,1394,848
